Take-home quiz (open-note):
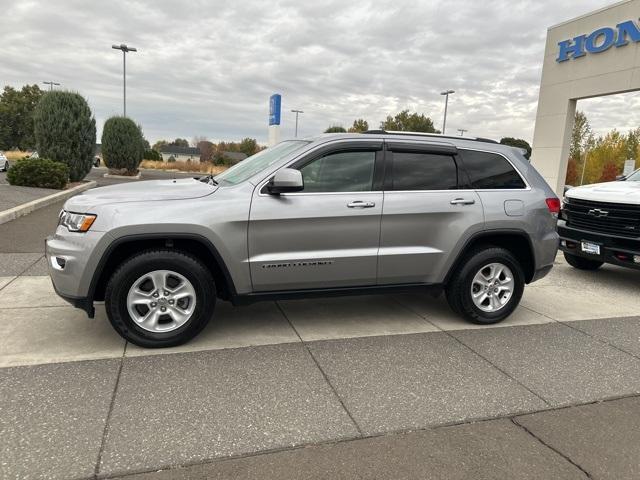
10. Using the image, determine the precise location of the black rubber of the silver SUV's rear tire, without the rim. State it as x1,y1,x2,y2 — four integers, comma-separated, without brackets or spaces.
445,246,524,325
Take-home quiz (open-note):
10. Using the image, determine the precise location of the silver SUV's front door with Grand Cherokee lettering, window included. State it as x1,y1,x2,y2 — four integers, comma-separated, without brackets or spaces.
249,142,383,292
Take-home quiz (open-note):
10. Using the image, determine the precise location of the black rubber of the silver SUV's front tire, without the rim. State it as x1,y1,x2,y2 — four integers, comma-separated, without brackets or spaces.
105,250,216,348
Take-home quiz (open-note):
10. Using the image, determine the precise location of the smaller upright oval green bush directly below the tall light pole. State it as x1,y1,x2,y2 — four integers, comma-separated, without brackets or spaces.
102,117,144,175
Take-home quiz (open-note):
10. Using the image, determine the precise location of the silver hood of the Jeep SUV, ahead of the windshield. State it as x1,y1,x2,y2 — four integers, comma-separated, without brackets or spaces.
64,178,218,212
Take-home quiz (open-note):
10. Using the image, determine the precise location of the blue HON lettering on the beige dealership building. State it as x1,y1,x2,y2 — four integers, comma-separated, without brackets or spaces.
556,20,640,62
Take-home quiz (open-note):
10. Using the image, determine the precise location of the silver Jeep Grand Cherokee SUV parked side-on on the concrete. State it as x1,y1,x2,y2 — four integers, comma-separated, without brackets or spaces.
46,131,560,347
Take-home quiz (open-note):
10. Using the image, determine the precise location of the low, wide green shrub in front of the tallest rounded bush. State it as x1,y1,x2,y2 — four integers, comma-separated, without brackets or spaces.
7,158,69,189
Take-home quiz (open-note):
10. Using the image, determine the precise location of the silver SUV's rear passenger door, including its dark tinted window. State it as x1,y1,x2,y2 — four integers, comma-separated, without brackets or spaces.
378,141,484,285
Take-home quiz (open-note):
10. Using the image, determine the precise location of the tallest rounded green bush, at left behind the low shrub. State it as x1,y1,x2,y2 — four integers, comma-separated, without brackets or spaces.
33,91,96,182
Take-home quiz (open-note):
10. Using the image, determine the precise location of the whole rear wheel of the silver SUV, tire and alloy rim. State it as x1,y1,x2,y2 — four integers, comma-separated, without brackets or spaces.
445,247,524,324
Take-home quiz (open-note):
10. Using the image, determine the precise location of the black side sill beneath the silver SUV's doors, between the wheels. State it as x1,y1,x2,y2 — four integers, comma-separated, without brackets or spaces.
231,283,444,305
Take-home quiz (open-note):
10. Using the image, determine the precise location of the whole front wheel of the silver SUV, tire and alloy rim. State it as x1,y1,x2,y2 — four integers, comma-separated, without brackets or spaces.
105,250,216,348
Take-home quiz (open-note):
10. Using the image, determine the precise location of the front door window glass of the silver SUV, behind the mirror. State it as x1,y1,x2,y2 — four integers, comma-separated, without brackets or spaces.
300,151,376,192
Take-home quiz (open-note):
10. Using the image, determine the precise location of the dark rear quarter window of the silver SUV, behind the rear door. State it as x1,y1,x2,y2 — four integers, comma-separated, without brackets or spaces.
462,150,525,189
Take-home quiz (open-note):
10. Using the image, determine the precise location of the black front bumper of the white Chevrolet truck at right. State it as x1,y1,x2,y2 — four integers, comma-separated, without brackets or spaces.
558,220,640,270
